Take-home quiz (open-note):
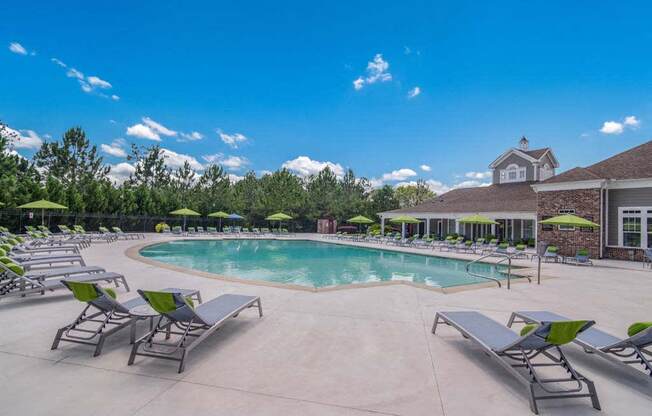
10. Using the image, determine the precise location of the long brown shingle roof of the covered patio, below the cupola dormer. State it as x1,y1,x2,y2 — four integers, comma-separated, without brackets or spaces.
388,182,537,213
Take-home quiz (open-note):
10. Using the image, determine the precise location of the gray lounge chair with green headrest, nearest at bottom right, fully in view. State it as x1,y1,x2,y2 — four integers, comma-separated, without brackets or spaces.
432,312,600,414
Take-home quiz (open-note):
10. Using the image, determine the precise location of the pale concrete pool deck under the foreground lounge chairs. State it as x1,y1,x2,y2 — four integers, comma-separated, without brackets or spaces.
0,235,652,416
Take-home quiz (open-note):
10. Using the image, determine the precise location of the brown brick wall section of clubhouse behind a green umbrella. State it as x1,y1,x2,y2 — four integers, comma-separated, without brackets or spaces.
537,189,601,258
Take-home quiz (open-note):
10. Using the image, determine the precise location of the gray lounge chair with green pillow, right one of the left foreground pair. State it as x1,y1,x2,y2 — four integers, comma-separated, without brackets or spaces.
128,290,263,373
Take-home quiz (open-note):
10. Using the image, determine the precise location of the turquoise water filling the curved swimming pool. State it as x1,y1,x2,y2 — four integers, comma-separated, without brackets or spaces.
140,239,503,288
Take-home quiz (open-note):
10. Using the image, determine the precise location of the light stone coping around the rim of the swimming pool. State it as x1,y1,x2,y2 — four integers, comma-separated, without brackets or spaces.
124,237,553,294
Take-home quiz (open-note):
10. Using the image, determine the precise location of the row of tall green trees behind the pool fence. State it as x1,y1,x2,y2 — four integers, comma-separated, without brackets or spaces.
0,123,435,231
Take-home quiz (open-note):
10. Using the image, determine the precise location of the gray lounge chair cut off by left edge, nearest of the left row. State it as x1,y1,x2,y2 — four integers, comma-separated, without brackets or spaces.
0,262,129,299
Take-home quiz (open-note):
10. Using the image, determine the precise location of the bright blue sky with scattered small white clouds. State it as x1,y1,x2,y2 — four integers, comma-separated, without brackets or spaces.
0,1,652,192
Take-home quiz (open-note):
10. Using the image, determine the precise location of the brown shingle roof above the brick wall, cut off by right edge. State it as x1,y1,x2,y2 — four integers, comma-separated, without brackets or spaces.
543,140,652,183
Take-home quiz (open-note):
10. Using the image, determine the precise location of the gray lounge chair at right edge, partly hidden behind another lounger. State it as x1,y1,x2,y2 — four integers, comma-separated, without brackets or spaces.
507,311,652,376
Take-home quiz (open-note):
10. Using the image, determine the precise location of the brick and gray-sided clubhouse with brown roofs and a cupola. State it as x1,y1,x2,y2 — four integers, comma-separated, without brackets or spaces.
379,137,652,260
